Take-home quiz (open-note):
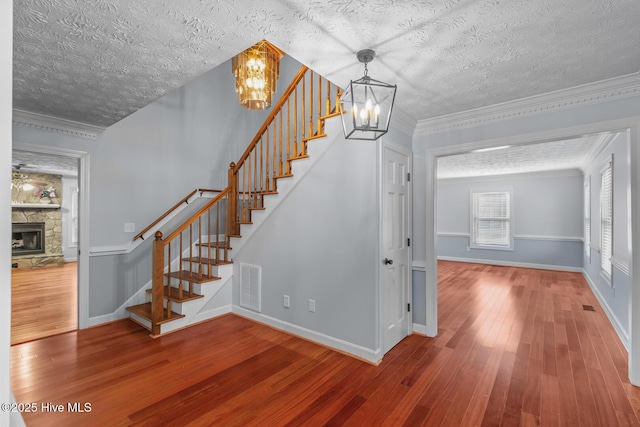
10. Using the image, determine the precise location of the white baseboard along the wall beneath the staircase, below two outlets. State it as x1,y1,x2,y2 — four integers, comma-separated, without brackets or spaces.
232,305,382,364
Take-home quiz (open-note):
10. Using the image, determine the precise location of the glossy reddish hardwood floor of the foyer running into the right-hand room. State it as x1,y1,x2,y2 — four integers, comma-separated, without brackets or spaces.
11,262,640,426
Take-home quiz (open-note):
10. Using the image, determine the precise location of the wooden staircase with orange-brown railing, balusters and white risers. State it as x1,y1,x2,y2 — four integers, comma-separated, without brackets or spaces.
127,66,341,337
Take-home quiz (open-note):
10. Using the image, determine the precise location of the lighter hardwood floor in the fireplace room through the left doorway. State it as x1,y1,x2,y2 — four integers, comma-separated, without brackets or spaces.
11,262,78,345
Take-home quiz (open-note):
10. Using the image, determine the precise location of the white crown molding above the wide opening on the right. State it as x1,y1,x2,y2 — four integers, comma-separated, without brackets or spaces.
414,73,640,137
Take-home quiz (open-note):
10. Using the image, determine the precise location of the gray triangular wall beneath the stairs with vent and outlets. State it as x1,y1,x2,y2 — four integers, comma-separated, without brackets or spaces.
233,135,379,350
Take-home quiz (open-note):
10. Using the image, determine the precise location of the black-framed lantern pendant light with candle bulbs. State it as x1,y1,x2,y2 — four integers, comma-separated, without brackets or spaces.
340,49,397,141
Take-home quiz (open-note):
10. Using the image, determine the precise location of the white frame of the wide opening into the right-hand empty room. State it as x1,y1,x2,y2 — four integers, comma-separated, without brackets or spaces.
425,116,640,386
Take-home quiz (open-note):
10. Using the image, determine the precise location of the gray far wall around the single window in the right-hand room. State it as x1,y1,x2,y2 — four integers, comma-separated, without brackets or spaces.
436,170,583,269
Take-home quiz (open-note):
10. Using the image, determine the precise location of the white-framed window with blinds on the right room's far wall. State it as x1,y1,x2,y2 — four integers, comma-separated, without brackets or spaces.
470,190,513,249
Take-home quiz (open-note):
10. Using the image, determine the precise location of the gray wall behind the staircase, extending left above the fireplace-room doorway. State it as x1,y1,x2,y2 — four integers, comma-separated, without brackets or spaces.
13,57,300,317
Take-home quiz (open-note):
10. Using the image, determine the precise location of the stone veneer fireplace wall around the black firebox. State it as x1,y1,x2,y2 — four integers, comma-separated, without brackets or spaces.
11,171,64,268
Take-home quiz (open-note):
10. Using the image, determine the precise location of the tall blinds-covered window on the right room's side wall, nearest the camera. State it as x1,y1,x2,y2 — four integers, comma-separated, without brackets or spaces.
600,159,613,281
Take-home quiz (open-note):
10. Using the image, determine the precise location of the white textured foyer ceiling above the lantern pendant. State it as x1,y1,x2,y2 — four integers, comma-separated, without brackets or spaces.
13,0,640,127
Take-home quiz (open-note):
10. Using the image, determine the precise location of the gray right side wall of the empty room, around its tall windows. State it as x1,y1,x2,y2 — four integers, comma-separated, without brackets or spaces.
584,131,632,339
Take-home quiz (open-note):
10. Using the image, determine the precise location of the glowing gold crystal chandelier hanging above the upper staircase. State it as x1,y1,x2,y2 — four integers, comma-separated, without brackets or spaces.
231,40,284,110
